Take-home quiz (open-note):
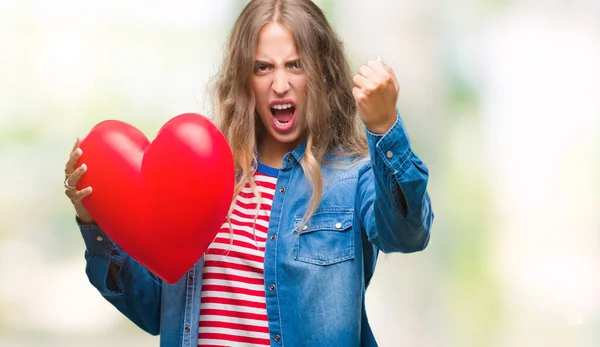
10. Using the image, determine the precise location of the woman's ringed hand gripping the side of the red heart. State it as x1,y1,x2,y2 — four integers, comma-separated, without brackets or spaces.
64,137,94,224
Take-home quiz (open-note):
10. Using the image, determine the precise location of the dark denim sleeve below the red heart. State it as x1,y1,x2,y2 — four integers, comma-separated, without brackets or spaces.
77,220,161,335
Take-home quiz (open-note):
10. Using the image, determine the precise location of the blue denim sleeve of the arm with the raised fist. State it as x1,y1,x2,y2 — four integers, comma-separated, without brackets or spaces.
358,114,433,253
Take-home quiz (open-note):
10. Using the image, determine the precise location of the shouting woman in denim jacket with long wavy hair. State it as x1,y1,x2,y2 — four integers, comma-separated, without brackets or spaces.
65,0,433,346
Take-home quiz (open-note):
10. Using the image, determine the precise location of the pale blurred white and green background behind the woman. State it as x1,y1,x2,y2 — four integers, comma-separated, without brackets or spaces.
0,0,600,347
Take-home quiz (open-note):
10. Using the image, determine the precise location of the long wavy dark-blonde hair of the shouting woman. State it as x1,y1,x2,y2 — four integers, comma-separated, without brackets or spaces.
214,0,368,232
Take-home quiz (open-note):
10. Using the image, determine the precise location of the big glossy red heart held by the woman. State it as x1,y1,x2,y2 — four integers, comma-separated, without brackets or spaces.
77,113,234,283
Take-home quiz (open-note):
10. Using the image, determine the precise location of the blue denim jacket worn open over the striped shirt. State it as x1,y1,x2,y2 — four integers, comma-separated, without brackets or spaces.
79,115,433,347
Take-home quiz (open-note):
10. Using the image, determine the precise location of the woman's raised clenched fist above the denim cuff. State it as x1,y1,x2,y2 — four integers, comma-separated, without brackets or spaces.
352,58,399,134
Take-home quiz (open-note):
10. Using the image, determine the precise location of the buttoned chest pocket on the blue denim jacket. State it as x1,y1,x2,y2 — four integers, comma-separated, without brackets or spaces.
294,210,354,265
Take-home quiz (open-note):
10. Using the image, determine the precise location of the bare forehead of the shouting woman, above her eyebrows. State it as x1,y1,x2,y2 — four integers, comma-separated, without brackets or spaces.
256,23,298,60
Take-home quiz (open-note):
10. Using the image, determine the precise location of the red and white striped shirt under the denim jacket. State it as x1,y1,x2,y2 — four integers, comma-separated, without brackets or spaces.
198,163,278,347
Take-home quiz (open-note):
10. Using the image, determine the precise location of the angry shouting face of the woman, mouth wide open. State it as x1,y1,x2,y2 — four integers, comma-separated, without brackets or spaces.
252,23,306,152
